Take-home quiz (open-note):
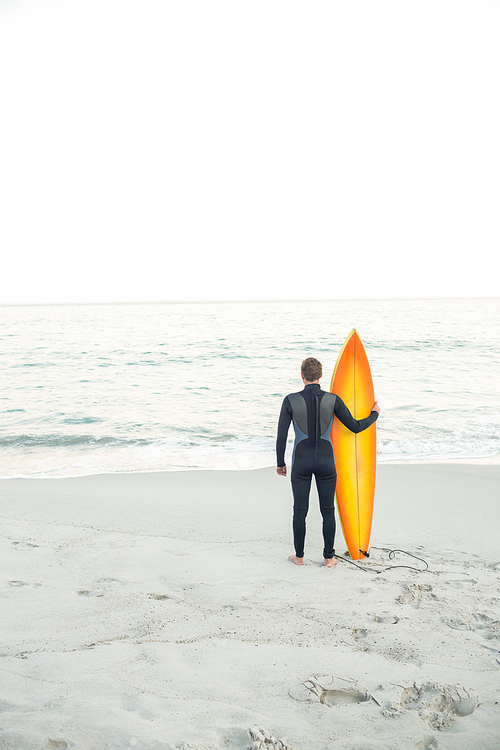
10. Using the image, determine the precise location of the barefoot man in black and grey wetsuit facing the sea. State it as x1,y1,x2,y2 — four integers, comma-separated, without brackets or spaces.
276,357,380,568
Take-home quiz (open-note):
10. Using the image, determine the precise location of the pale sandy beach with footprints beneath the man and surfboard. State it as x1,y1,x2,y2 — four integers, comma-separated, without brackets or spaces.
0,464,500,750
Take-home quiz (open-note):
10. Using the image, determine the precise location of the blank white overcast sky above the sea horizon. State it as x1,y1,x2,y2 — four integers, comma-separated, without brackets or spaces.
0,0,500,303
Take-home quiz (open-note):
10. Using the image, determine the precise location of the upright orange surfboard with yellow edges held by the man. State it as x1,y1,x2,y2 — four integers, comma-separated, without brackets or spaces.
330,328,377,560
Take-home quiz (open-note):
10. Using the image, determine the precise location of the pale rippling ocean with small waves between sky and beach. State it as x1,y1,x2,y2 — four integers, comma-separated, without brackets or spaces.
0,298,500,477
